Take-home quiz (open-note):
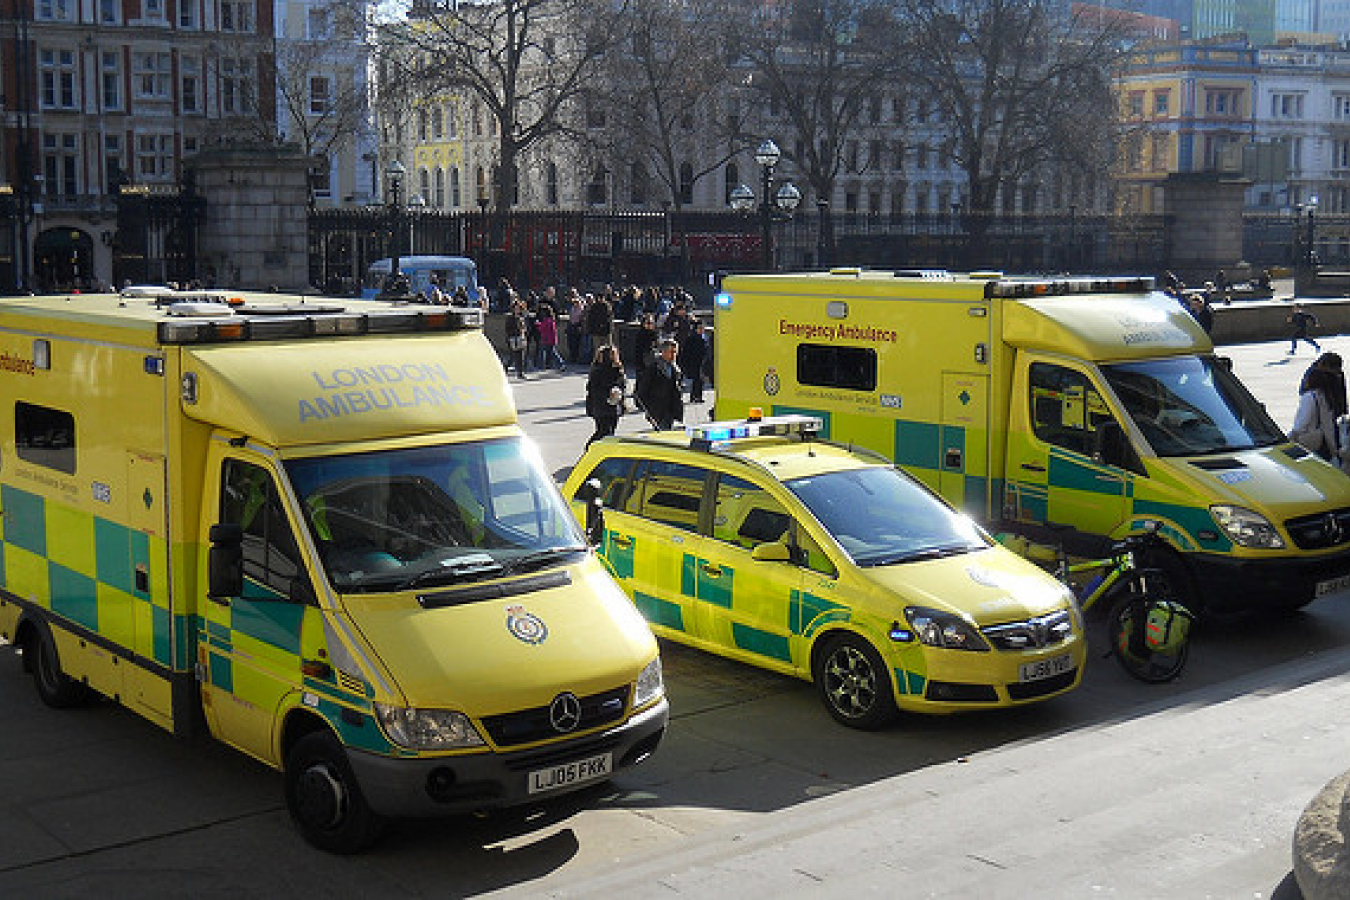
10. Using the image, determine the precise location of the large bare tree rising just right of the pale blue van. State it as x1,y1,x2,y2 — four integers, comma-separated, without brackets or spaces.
392,0,624,213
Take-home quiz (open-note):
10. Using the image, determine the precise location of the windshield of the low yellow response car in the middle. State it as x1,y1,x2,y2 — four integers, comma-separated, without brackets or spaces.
786,466,990,567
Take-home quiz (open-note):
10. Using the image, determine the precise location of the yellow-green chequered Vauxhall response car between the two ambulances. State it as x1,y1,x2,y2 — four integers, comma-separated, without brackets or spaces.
563,416,1085,729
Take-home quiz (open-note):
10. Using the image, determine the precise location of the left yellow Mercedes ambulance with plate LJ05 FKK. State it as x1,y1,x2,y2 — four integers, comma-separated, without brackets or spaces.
0,289,668,853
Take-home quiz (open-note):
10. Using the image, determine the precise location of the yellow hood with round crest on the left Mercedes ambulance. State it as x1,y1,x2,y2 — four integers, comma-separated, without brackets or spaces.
347,556,656,718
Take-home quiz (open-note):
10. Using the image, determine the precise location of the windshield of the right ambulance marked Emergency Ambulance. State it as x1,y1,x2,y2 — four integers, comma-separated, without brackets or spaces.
1102,356,1284,456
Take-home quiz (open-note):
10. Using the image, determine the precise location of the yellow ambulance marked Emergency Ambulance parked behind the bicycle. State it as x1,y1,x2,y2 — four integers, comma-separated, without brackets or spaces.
716,269,1350,611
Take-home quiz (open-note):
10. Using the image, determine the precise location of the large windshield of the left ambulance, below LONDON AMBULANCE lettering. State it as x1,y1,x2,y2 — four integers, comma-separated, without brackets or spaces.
286,439,586,592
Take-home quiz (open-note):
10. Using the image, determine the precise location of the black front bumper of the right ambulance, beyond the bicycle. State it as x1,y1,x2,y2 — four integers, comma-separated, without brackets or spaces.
1188,549,1350,613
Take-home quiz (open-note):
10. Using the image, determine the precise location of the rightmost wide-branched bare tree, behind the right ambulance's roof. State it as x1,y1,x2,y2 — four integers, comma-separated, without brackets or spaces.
896,0,1130,232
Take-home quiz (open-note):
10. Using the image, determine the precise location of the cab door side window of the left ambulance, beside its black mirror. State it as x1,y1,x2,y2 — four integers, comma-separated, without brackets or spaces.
220,459,304,600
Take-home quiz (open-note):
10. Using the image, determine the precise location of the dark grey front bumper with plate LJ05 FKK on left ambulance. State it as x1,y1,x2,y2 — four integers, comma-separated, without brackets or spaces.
347,698,670,818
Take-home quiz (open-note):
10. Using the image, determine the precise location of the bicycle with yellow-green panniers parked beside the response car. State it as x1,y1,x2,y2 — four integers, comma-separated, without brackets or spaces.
1003,522,1195,684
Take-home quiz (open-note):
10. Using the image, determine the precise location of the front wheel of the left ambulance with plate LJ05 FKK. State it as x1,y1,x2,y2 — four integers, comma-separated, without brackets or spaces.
286,731,385,855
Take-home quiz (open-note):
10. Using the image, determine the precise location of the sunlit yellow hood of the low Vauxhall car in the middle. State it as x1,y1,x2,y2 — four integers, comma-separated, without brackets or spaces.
861,545,1069,627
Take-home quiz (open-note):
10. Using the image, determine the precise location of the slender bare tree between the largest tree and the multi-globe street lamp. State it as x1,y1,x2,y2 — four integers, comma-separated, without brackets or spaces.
599,0,736,210
